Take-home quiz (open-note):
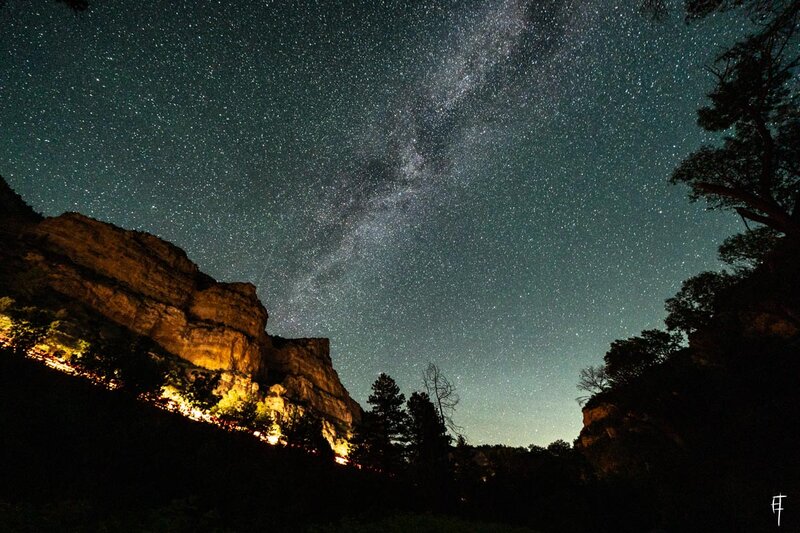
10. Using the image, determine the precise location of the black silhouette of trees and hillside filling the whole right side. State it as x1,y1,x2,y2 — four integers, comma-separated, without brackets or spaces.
576,0,800,531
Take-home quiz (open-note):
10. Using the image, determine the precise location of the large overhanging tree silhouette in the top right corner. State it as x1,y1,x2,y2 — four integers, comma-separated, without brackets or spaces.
671,0,800,240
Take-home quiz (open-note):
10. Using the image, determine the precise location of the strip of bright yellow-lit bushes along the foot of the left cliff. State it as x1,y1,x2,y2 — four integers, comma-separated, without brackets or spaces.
0,296,349,464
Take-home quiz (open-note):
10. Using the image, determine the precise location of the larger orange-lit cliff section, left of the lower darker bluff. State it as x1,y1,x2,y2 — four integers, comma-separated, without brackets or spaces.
27,213,269,375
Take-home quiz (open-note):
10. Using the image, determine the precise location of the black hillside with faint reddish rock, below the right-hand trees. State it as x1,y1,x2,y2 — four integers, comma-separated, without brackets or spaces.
579,240,800,531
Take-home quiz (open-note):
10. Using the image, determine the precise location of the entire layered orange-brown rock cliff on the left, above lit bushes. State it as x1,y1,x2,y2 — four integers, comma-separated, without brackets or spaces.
0,178,361,434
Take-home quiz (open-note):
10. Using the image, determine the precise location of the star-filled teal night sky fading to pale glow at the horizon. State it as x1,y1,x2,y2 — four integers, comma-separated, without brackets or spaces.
0,0,742,446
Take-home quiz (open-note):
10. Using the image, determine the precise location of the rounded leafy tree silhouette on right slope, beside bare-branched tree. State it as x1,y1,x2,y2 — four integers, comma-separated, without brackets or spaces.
604,329,681,385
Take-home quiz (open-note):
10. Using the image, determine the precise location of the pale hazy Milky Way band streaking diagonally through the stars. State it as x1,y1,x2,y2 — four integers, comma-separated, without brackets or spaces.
283,1,584,328
